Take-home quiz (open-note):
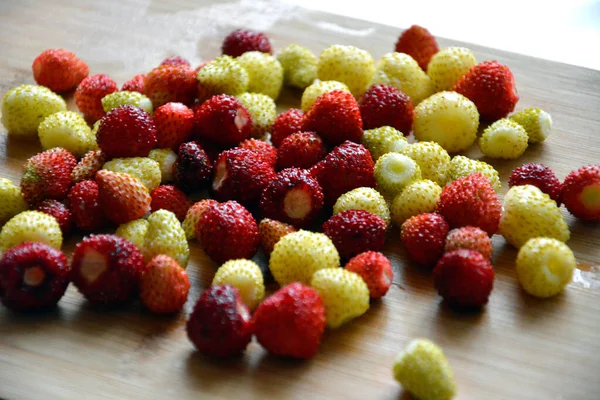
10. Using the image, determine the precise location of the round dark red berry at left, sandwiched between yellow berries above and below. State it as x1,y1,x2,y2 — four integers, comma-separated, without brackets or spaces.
96,106,157,158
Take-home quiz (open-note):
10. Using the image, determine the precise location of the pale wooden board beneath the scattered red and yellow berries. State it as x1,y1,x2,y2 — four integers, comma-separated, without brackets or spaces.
0,0,600,400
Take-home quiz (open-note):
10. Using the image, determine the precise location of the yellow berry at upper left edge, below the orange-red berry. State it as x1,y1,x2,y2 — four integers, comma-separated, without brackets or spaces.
2,85,67,136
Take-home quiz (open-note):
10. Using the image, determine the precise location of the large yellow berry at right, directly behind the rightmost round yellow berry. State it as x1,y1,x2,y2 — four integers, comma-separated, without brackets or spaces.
500,185,571,248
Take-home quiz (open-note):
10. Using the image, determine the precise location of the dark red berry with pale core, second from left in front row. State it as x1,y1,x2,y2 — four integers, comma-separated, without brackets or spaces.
71,235,144,306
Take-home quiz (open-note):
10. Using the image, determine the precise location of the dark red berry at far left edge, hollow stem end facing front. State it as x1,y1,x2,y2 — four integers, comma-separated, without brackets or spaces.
0,242,69,311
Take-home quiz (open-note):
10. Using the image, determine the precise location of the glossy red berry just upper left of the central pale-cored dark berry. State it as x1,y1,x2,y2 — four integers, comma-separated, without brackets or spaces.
212,148,275,205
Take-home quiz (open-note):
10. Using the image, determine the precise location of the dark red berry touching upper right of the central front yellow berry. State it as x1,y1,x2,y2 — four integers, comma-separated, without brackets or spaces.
323,210,387,259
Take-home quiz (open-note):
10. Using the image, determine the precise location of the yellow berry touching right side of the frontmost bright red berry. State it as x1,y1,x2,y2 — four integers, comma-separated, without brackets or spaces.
310,268,369,328
